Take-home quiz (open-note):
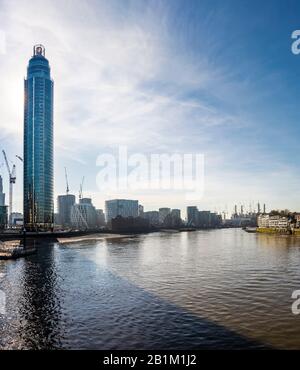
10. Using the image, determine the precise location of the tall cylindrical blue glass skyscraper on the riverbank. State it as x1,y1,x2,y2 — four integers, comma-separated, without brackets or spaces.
24,45,53,230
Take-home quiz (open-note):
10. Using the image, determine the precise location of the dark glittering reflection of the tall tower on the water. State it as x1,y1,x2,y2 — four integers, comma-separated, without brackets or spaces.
0,245,63,349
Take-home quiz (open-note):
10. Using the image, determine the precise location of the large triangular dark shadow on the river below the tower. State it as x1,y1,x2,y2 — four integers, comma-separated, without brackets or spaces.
0,246,270,350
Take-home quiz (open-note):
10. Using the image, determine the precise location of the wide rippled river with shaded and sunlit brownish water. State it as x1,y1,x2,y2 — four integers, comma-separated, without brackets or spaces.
0,229,300,350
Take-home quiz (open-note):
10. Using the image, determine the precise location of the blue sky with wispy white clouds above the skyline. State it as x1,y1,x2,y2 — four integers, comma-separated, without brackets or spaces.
0,0,300,215
